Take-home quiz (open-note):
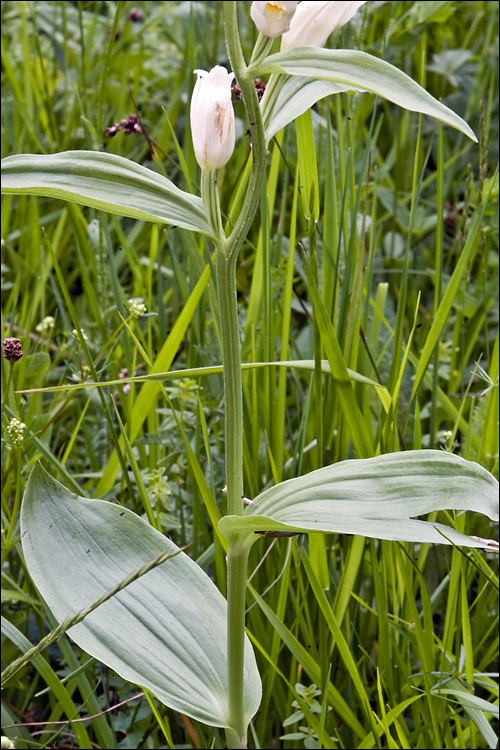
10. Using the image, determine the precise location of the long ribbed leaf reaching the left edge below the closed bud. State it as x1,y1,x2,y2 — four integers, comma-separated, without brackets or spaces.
2,151,213,236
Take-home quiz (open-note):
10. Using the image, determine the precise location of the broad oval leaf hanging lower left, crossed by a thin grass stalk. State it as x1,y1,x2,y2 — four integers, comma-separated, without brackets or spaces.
21,464,261,727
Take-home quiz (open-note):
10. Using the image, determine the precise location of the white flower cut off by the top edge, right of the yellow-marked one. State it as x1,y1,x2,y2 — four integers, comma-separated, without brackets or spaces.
281,0,366,51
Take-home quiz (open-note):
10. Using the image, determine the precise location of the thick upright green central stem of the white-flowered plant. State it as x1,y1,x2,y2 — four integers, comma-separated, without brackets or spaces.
214,1,268,749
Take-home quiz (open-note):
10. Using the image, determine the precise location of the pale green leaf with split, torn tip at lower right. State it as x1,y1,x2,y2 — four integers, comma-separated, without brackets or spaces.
219,450,498,549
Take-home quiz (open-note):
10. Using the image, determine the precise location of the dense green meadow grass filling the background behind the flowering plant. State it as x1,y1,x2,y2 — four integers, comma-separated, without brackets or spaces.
1,0,499,749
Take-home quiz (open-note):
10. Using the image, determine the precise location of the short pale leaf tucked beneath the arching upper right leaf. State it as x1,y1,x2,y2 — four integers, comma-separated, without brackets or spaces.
261,76,353,143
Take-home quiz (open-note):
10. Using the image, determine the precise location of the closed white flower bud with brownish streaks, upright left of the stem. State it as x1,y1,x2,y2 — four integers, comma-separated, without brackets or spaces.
191,65,235,171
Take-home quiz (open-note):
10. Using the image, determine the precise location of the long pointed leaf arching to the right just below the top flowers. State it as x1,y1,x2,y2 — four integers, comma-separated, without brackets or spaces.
250,47,477,141
